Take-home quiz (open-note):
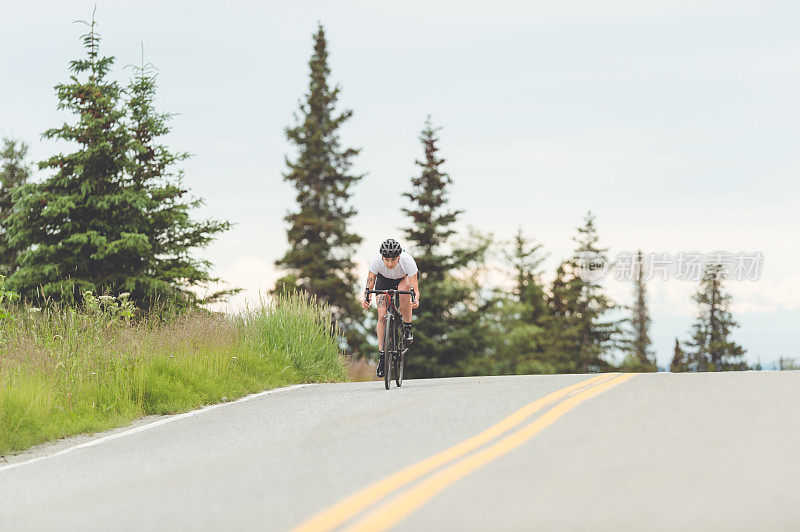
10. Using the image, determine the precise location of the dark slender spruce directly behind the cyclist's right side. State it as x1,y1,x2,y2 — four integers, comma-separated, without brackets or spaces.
402,117,489,377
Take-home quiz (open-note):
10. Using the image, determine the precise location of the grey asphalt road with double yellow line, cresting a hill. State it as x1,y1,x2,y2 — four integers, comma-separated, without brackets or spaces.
0,372,800,531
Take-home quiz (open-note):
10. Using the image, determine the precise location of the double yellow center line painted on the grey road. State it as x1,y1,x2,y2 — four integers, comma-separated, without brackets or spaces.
293,374,633,532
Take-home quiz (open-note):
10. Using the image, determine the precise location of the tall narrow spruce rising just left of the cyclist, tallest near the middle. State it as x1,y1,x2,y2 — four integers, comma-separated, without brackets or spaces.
275,25,363,332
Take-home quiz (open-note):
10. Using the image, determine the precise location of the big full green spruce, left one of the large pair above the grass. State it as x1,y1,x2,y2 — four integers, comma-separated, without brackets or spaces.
8,19,133,299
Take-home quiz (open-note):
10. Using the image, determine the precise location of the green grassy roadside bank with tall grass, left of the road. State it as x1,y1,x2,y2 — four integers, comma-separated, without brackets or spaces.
0,295,347,455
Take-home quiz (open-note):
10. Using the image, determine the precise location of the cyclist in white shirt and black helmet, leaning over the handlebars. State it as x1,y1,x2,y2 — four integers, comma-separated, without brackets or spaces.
361,238,419,377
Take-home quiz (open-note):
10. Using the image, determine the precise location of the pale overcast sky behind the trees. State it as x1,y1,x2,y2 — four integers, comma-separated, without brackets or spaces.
0,0,800,365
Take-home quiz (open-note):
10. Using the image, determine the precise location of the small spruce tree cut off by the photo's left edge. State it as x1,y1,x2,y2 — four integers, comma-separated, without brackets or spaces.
0,138,31,277
